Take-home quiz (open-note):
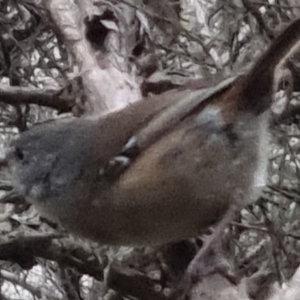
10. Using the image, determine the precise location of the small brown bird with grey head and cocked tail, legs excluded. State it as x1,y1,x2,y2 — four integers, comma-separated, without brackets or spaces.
2,20,300,245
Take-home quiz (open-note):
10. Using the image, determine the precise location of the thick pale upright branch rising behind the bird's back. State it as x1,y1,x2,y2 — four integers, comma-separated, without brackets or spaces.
45,0,141,115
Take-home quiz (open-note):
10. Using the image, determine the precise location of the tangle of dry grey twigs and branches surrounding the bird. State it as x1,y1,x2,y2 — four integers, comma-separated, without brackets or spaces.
0,0,300,300
